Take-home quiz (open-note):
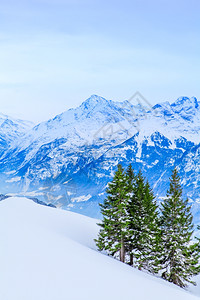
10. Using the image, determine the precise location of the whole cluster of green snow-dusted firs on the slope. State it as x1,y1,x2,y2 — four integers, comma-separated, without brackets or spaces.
95,165,200,287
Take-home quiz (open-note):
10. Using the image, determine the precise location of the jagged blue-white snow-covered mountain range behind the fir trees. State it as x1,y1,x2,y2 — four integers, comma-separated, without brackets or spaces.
0,95,200,221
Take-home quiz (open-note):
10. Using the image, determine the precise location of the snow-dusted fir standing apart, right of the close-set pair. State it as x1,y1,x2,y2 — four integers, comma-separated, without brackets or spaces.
161,168,200,287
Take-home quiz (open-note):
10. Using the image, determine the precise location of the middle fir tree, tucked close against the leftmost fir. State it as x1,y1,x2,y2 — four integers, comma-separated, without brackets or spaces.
127,171,159,272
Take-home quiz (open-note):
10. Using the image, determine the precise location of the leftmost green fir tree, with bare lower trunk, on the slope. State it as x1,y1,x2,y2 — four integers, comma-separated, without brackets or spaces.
96,165,128,262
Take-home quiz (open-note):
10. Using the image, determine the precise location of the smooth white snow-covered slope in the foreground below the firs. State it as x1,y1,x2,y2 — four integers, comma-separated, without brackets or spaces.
0,198,199,300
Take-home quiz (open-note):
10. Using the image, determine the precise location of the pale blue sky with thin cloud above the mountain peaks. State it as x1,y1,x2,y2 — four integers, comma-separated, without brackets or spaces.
0,0,200,122
